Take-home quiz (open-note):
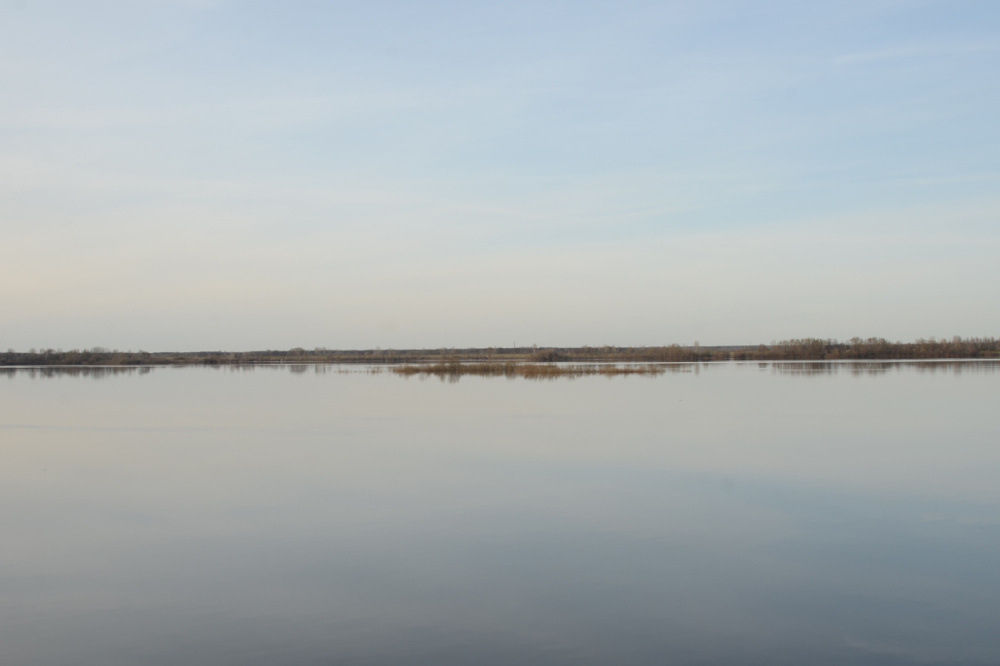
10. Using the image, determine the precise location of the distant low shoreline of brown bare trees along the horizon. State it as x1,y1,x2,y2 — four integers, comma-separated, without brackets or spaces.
0,337,1000,366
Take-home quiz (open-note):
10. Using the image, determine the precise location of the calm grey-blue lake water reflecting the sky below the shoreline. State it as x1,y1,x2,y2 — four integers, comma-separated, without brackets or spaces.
0,362,1000,666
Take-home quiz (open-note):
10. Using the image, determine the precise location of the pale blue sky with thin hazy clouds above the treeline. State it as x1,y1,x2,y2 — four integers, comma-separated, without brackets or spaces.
0,0,1000,351
